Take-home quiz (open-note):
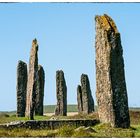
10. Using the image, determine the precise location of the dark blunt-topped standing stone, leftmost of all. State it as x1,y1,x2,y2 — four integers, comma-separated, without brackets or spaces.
16,61,27,117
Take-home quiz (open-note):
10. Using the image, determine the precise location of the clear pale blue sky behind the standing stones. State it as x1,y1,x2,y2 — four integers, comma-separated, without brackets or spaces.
0,3,140,111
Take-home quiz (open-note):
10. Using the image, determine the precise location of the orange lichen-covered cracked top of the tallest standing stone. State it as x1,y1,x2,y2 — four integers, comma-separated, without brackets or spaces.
95,14,119,33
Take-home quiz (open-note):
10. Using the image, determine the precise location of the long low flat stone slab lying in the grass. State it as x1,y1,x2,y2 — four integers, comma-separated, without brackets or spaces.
0,119,99,129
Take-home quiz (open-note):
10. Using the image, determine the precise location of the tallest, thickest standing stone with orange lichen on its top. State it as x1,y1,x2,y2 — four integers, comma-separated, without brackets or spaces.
95,15,130,128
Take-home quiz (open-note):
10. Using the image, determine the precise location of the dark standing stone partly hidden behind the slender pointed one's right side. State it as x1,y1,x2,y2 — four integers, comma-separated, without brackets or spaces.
35,65,45,116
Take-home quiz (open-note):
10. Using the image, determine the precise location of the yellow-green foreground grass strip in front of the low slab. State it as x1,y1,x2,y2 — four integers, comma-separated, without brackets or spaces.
0,124,140,138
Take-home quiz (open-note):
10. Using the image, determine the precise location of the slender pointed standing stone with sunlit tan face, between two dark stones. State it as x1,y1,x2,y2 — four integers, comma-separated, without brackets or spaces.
26,39,38,120
